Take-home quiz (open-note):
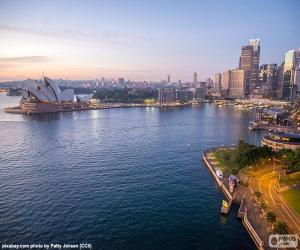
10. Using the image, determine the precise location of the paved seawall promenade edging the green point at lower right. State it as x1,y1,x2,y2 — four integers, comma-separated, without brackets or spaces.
202,147,268,250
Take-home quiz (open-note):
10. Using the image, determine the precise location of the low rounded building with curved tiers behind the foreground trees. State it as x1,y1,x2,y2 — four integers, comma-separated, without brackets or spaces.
261,132,300,151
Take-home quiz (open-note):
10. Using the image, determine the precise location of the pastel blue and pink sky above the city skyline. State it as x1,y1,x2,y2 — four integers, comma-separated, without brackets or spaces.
0,0,300,81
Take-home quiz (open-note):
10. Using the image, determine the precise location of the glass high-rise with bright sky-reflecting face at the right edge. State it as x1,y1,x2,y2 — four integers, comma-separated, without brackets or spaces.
282,49,300,101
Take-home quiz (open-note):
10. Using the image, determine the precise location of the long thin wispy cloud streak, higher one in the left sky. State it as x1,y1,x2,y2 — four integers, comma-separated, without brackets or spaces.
0,24,154,45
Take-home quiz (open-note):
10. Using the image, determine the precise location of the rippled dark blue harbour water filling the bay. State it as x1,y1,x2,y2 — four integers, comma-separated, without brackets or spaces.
0,94,262,249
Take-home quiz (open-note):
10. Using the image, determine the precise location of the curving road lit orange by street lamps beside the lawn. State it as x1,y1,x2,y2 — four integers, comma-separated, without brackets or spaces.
249,168,300,236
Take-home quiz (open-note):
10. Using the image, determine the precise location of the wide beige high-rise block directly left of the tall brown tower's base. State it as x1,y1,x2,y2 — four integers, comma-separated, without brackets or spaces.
229,69,245,98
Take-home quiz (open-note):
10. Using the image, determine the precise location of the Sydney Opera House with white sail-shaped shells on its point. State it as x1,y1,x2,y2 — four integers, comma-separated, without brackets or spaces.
6,77,90,114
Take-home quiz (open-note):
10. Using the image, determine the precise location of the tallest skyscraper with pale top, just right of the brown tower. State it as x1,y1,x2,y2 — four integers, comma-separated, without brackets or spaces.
249,39,260,93
